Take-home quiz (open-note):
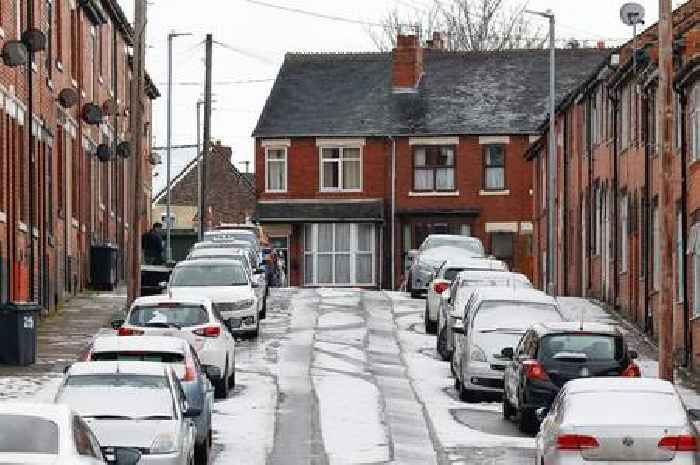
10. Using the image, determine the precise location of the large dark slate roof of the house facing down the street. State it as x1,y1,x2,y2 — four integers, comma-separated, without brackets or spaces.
253,49,610,137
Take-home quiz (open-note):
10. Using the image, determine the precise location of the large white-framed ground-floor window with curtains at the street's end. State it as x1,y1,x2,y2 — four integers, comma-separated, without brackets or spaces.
302,223,377,287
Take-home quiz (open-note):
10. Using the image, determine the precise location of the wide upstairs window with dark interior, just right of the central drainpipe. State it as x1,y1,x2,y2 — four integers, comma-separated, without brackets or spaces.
413,146,455,192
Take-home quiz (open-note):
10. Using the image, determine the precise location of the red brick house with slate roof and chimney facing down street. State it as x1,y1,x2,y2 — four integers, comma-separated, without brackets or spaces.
253,36,608,288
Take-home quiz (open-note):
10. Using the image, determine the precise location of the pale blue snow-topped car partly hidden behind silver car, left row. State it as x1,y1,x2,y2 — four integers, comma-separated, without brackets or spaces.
87,336,213,464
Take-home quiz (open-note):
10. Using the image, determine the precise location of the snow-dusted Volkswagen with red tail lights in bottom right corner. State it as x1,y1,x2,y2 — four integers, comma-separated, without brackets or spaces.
536,378,697,465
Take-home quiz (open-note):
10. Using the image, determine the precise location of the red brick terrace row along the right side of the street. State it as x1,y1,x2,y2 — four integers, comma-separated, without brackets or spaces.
526,0,700,367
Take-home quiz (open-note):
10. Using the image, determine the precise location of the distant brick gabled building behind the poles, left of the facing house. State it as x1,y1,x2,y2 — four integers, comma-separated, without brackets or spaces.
152,143,255,259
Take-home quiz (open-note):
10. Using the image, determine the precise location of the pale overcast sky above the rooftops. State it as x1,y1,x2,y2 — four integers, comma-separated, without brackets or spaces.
119,0,683,191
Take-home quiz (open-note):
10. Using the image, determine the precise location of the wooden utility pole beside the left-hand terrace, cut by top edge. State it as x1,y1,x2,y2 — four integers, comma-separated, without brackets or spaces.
127,0,146,305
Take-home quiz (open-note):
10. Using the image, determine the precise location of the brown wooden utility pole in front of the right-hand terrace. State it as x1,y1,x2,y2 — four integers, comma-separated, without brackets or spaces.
656,0,675,381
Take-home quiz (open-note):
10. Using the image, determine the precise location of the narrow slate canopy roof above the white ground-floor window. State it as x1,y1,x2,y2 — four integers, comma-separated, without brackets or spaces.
256,200,384,223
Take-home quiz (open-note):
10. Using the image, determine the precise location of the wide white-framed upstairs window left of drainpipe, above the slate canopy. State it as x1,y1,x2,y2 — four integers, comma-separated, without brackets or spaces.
320,147,362,191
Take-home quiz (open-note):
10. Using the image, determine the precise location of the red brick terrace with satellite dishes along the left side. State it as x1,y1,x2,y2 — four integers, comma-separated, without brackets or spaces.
0,0,158,309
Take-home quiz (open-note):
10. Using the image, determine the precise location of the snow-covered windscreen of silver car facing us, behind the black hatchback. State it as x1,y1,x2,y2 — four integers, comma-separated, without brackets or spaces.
472,301,563,329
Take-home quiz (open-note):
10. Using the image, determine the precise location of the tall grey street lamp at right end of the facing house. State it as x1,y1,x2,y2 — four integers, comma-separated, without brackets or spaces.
525,10,557,295
